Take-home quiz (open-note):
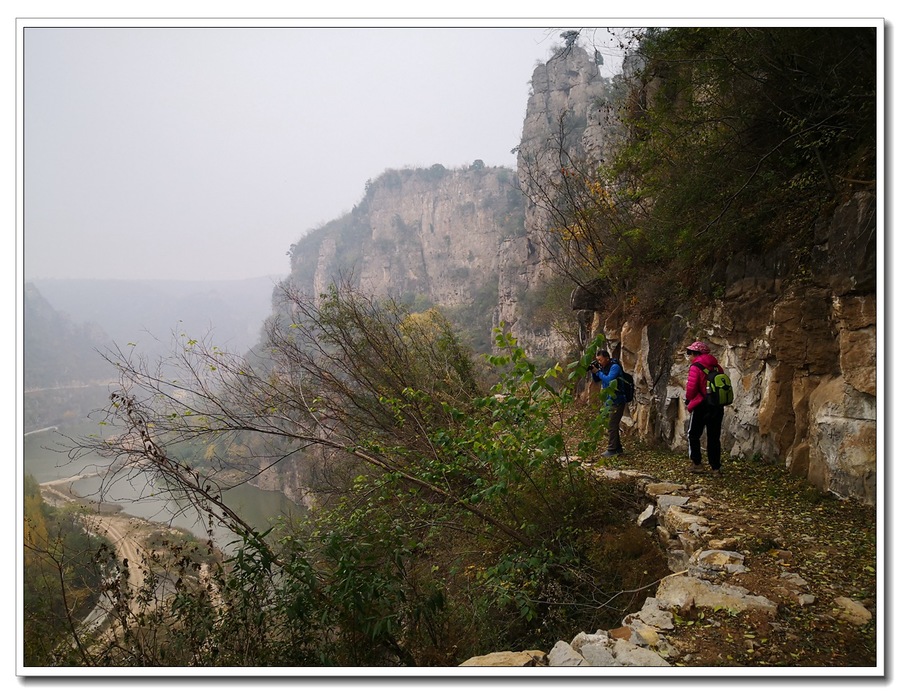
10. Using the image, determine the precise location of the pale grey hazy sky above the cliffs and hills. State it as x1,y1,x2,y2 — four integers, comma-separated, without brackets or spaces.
23,25,618,280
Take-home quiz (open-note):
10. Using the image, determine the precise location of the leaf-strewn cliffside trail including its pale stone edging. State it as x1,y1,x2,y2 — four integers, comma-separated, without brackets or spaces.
463,451,884,674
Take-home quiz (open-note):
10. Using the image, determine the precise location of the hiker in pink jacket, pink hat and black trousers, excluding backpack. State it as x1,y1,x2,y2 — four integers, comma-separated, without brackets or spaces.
684,341,725,475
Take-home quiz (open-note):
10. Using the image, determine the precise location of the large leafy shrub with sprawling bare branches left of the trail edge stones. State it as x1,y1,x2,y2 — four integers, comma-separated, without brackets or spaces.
61,287,668,666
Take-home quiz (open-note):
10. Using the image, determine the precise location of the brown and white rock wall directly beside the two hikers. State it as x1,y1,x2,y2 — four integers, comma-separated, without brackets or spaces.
587,193,877,504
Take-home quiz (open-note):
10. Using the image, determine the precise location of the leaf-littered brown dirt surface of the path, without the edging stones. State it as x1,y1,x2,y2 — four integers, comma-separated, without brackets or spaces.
596,450,882,667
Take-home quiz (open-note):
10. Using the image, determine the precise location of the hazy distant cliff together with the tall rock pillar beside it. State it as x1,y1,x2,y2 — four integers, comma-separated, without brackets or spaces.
291,46,613,355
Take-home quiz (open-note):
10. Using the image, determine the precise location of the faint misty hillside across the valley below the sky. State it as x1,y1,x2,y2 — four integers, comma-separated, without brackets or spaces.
23,277,276,430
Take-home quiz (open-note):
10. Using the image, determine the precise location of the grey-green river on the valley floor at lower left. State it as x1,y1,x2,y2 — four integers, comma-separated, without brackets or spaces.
23,428,304,552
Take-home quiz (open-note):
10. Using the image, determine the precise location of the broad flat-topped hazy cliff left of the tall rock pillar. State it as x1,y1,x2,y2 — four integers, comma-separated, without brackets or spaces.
291,162,524,354
